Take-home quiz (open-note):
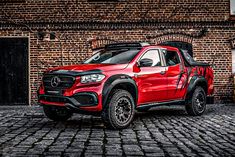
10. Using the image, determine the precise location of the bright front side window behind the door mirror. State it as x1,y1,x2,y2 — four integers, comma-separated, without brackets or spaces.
140,50,161,67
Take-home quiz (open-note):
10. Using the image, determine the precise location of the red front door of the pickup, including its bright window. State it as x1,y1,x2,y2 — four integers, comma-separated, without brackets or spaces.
134,49,167,104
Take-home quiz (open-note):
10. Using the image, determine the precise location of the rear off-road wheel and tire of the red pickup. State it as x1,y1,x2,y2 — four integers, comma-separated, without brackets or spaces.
185,86,206,116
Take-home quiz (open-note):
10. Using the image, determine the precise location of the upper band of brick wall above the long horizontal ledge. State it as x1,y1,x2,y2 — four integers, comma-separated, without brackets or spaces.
0,0,230,22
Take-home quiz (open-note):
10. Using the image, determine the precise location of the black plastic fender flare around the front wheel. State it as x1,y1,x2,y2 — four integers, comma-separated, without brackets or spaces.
102,74,138,107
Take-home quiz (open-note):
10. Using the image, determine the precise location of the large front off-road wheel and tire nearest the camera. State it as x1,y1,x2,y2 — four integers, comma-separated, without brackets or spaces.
101,89,135,129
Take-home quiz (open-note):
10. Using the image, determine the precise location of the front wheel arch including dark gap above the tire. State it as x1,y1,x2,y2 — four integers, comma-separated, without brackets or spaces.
102,74,138,107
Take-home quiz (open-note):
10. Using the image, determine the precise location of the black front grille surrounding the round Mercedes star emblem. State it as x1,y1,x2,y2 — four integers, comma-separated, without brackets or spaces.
43,75,75,89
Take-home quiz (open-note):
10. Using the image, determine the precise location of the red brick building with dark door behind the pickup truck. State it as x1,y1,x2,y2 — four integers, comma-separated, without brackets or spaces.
0,0,235,104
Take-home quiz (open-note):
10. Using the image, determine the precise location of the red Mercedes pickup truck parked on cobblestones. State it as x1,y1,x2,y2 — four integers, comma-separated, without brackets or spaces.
38,42,214,129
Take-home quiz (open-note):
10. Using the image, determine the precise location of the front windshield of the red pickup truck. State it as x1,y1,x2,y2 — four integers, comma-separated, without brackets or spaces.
84,49,139,64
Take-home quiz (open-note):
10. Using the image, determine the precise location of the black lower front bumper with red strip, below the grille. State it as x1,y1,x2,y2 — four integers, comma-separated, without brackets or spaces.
39,92,98,109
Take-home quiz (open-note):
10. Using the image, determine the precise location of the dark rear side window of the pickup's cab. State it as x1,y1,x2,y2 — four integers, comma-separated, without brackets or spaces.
164,51,180,66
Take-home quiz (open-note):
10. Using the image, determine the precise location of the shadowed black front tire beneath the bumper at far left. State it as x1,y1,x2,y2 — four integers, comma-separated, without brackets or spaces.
43,105,73,121
